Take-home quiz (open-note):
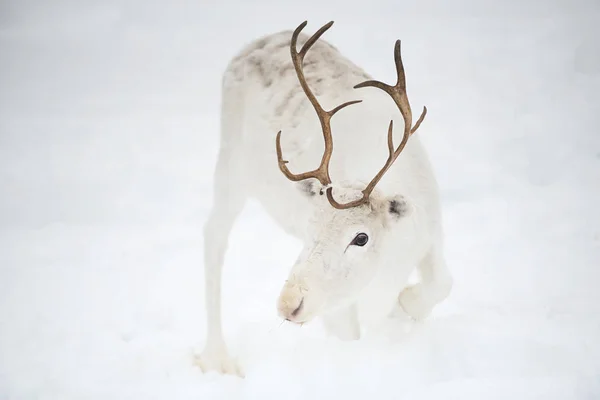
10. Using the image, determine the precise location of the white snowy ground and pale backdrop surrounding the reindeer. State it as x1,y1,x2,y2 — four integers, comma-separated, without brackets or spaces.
0,0,600,400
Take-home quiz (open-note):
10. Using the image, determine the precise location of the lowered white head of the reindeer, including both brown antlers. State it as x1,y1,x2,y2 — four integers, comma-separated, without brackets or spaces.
276,21,427,323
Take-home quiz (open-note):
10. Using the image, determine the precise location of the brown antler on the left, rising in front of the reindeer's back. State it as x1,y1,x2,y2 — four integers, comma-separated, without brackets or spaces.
275,21,361,186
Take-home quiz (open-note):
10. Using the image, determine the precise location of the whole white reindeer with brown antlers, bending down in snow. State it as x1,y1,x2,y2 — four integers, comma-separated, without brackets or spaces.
196,21,452,376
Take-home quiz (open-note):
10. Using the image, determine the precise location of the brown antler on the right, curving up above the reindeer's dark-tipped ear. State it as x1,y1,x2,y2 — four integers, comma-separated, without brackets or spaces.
327,40,427,209
